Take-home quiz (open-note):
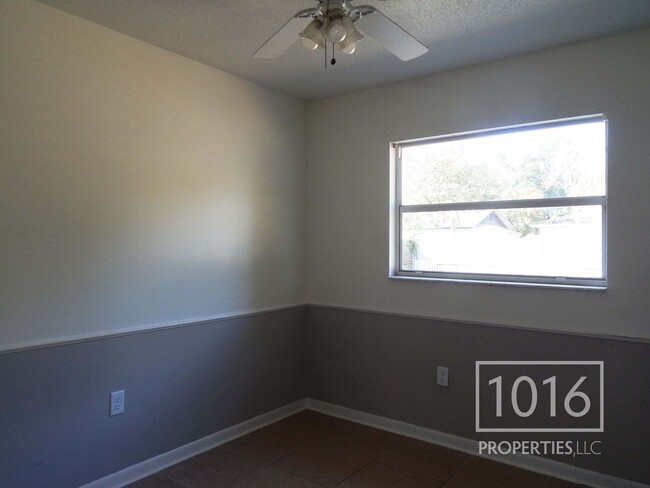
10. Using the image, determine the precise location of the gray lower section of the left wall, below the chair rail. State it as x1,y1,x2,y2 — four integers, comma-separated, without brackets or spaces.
0,307,305,488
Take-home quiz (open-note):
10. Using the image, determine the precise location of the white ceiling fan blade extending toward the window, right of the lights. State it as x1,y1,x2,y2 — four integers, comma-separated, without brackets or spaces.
355,9,429,61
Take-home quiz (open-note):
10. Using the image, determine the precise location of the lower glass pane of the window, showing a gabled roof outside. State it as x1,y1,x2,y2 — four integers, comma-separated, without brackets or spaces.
401,205,603,279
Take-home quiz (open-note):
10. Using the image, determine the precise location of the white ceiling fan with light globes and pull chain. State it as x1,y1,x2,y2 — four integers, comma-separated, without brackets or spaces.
253,0,428,64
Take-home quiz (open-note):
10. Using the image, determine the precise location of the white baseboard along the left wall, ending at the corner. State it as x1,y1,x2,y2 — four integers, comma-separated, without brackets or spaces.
81,399,306,488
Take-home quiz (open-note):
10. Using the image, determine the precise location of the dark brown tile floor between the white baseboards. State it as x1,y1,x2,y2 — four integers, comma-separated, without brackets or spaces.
128,410,584,488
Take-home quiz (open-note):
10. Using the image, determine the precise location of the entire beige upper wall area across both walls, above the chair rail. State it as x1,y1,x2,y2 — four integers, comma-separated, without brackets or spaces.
0,0,650,349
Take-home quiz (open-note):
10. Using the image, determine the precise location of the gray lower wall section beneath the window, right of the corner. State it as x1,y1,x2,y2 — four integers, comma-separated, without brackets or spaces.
307,306,650,483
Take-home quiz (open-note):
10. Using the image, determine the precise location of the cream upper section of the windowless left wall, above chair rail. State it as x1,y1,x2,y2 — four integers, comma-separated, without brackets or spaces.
0,0,306,349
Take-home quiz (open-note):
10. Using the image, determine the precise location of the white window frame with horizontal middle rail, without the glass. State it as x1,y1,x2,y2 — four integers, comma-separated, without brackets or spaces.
389,114,609,291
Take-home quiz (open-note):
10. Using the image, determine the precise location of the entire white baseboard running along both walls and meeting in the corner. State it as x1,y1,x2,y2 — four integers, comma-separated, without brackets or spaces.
81,398,650,488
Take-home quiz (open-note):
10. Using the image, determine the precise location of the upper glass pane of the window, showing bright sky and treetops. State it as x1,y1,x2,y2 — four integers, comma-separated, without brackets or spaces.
401,120,606,205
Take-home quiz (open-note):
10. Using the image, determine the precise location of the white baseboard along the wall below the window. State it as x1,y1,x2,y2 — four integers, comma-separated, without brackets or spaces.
306,398,650,488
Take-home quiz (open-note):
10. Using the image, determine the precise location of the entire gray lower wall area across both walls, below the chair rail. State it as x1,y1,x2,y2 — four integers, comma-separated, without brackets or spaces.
0,306,650,488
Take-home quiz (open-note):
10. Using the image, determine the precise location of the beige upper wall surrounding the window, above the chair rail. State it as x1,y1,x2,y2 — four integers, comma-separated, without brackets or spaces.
307,26,650,338
